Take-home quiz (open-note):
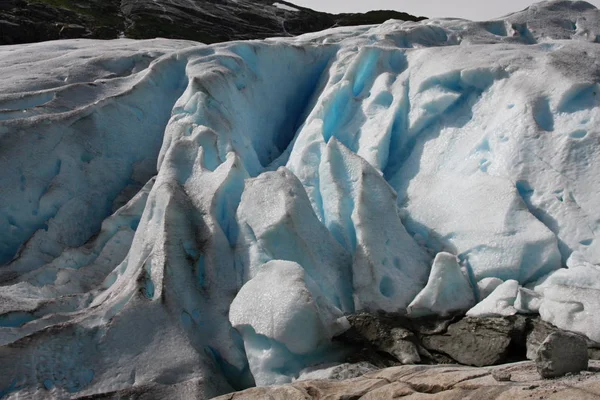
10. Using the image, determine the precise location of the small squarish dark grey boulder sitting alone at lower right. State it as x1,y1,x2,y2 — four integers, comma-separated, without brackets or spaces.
535,332,589,379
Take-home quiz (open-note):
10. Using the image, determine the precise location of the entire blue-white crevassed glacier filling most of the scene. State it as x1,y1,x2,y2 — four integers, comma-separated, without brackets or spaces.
0,1,600,398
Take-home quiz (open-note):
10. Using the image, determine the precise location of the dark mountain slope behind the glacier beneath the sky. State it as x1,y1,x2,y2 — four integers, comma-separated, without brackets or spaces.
0,0,424,45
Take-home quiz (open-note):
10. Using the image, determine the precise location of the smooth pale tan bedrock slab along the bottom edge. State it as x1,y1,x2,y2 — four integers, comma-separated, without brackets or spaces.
211,362,600,400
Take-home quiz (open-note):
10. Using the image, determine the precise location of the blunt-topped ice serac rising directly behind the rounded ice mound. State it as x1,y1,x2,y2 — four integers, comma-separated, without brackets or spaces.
236,167,354,313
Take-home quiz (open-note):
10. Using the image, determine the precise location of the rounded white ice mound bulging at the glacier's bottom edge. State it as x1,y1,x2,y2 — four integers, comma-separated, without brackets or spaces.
229,260,347,385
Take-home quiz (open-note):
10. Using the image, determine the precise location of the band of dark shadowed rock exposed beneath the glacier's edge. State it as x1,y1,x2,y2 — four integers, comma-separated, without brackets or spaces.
336,313,527,367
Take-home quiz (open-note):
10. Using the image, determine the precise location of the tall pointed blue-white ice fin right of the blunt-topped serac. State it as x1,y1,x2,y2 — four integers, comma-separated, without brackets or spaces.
318,138,429,312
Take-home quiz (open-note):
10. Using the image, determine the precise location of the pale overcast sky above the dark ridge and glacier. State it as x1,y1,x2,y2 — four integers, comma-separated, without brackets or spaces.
288,0,600,20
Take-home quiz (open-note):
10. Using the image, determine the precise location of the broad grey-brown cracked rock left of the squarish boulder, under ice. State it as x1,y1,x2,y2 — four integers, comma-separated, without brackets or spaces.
422,316,526,367
